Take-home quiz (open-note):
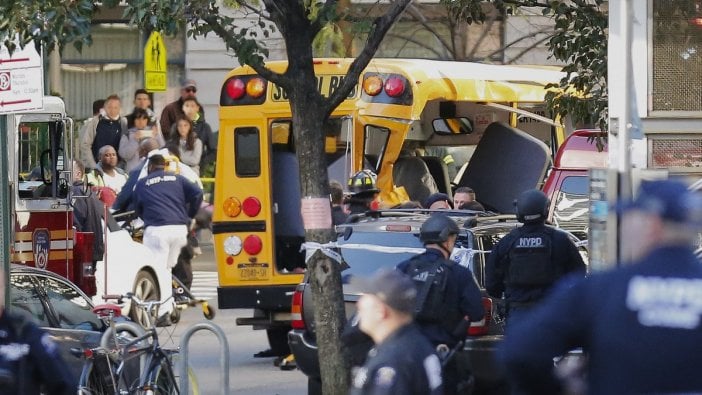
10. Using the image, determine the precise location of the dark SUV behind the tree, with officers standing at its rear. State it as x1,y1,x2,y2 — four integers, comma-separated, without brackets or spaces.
288,210,585,394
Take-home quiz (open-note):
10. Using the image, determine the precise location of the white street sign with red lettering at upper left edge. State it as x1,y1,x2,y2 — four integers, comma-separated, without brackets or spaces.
0,42,44,114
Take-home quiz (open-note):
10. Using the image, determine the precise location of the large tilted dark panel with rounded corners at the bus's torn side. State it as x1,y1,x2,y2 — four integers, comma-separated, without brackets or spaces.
458,122,551,213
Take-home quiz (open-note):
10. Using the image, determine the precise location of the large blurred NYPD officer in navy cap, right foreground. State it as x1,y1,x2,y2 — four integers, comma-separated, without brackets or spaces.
498,180,702,394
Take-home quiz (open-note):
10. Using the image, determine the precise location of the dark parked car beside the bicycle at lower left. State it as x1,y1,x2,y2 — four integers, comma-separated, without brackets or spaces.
7,264,140,378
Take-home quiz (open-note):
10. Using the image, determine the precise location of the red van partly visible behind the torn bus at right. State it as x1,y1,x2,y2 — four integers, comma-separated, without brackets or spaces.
543,130,607,240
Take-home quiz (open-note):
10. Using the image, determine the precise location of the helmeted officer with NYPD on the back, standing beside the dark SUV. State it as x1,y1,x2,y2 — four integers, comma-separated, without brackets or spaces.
485,189,585,324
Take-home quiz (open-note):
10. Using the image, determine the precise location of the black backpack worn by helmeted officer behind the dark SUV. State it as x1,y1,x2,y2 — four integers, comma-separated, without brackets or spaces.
405,258,449,323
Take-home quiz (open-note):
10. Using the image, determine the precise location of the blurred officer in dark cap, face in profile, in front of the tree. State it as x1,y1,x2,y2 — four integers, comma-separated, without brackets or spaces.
350,270,443,395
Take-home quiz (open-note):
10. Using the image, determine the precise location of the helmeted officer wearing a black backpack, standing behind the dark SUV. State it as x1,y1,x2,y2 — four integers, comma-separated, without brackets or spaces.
397,214,485,394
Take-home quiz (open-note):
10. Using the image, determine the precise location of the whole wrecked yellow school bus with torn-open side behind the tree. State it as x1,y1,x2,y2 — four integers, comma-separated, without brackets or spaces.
212,59,561,354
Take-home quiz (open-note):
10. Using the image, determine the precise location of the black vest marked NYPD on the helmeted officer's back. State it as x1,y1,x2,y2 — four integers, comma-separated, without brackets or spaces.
507,227,559,287
